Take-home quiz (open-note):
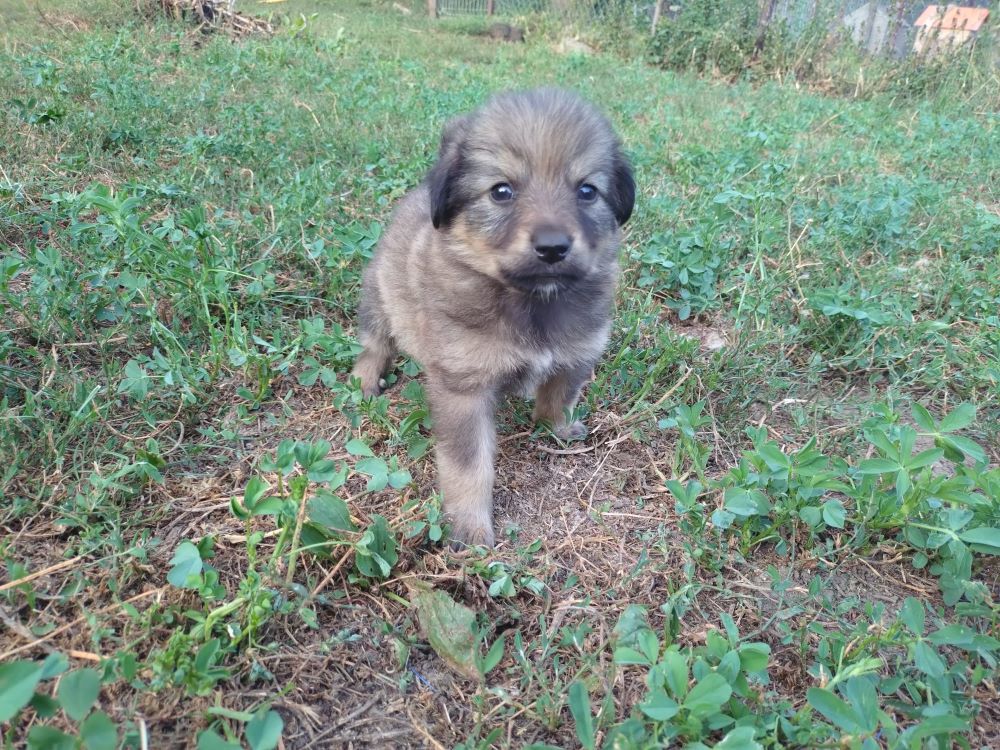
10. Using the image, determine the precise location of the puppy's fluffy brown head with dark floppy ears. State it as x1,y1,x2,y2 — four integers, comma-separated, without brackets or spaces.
428,90,635,297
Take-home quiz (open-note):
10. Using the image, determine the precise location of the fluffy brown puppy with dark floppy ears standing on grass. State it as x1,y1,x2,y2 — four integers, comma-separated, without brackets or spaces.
353,89,635,546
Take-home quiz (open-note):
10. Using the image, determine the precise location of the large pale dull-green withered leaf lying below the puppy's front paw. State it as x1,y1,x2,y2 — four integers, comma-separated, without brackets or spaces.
407,581,481,680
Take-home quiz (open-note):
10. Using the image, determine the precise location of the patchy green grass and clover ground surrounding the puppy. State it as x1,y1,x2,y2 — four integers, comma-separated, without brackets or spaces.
0,0,1000,750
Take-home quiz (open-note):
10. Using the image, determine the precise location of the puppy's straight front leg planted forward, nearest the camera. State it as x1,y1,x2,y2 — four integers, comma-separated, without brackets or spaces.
428,377,496,547
